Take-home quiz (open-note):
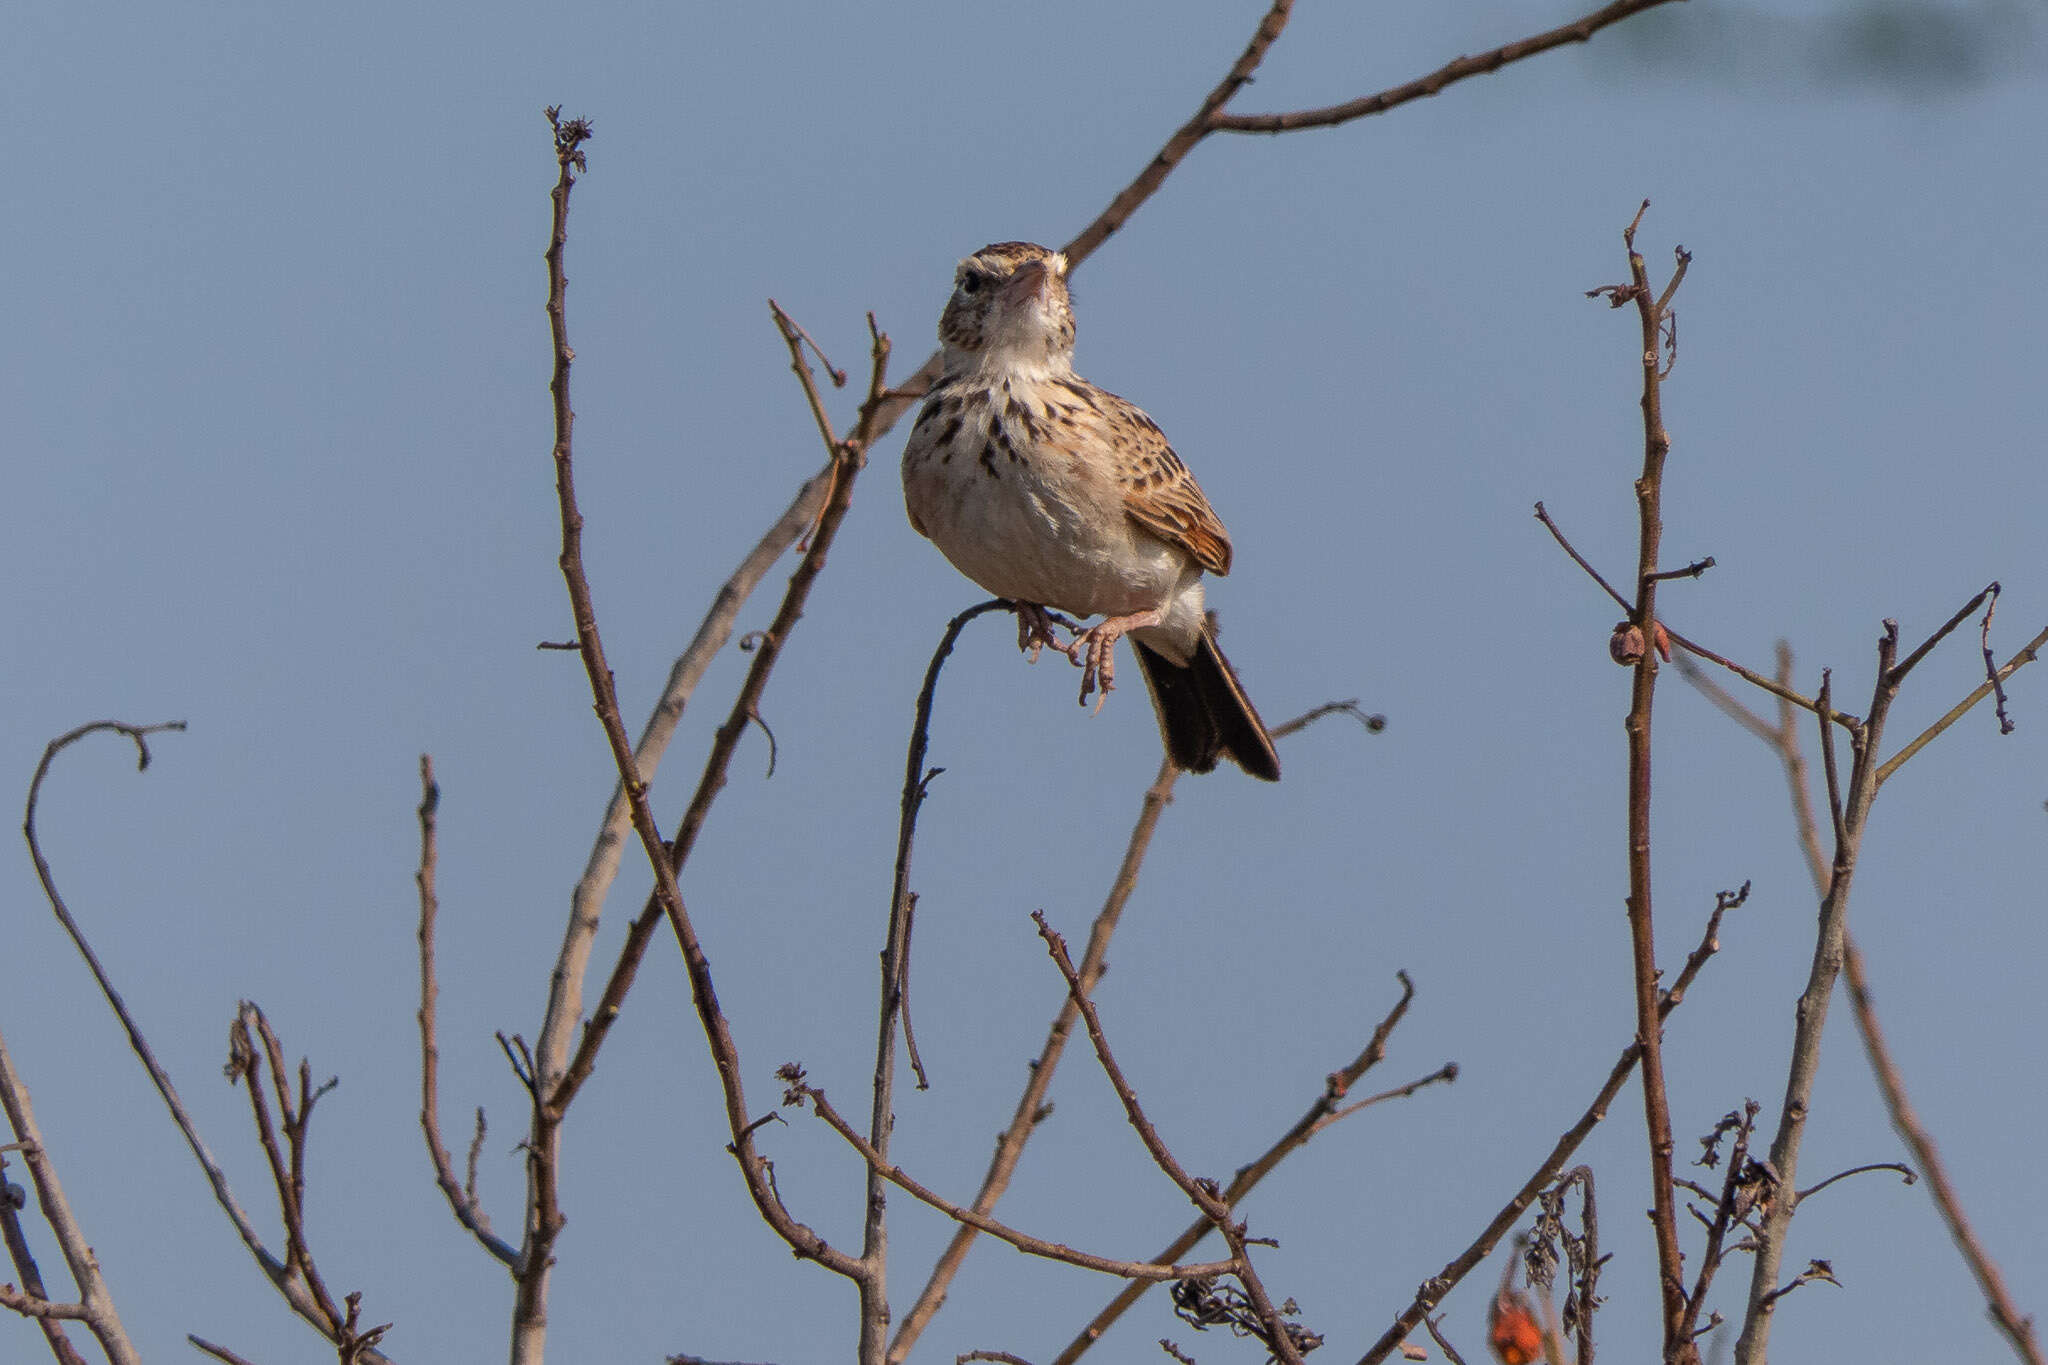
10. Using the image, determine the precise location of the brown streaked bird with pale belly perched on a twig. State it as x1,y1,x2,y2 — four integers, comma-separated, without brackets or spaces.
903,241,1280,782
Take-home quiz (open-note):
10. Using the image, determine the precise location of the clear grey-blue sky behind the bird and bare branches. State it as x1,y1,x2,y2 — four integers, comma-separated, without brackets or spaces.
0,0,2048,1365
